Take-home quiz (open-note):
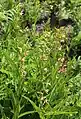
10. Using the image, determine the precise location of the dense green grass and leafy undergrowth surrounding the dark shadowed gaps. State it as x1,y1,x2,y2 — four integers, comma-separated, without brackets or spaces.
0,0,81,119
